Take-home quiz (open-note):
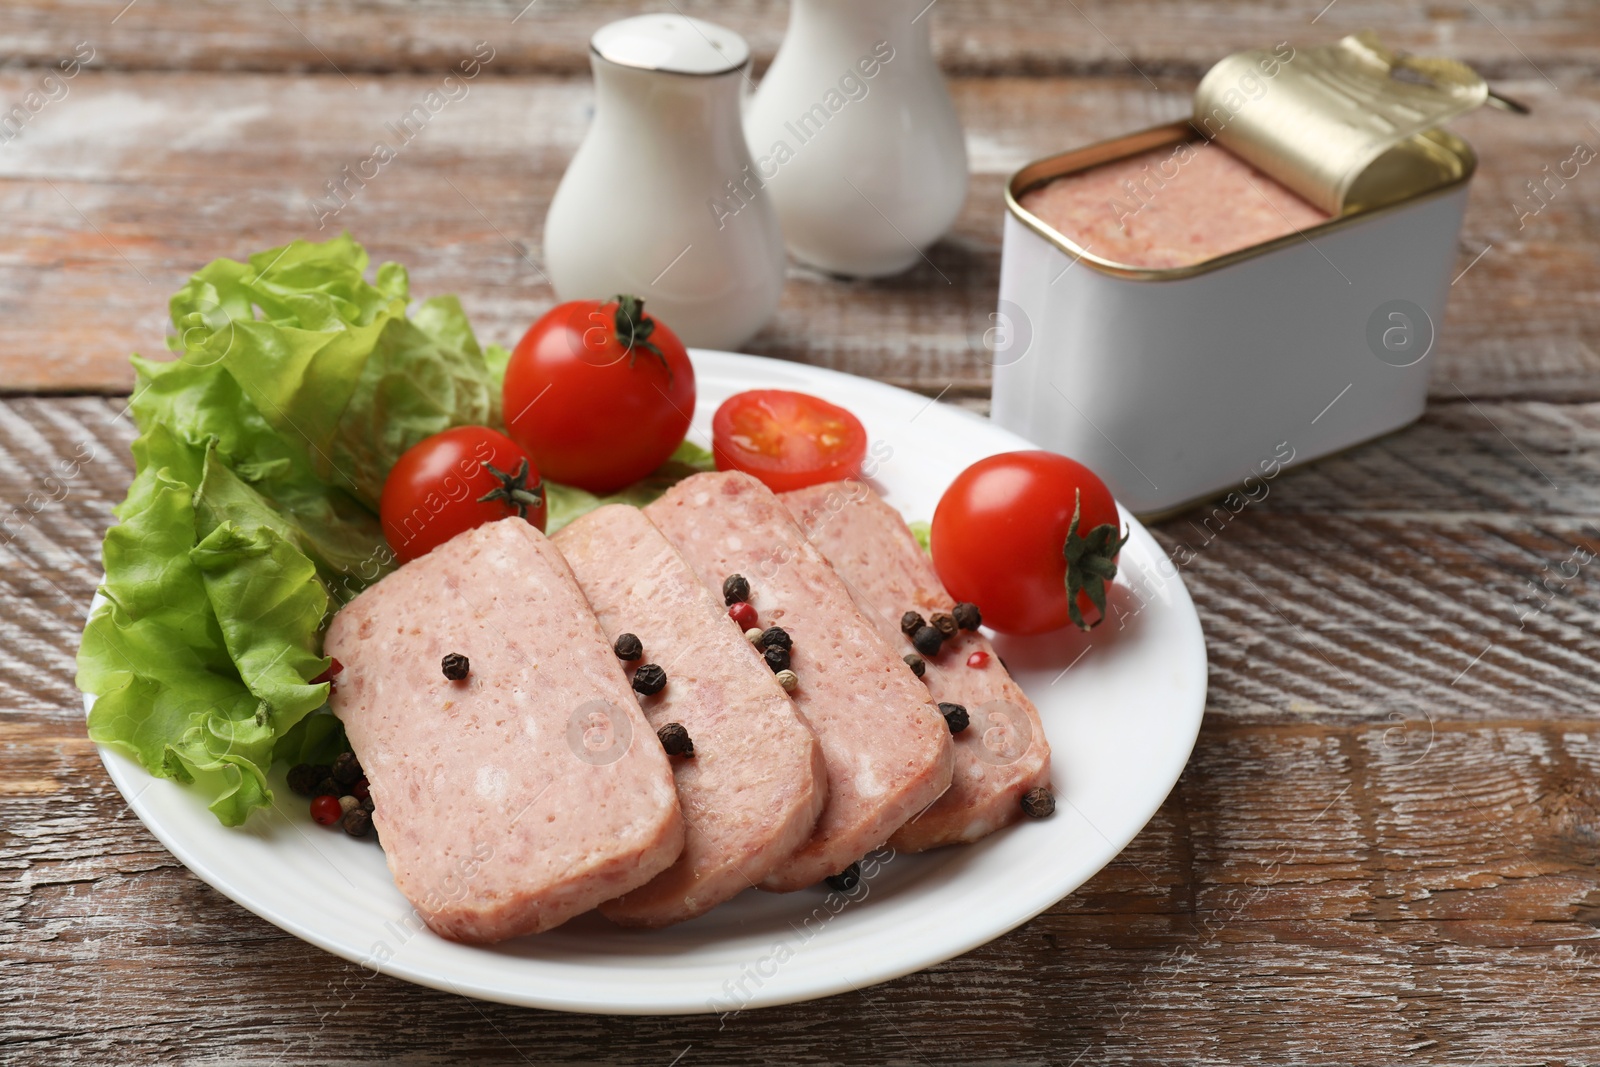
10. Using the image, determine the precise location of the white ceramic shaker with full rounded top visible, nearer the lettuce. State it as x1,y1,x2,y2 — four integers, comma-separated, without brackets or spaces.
544,14,784,349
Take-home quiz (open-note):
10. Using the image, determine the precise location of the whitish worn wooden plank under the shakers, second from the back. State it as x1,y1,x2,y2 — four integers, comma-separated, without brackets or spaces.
0,70,1600,398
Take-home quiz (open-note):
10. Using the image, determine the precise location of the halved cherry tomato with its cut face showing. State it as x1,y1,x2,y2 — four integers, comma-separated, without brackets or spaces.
710,389,867,493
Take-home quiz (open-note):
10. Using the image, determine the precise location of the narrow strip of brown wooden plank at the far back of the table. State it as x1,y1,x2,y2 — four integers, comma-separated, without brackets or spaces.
0,0,1600,83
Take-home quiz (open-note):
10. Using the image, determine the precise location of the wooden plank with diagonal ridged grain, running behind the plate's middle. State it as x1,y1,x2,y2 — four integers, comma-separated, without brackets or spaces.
0,398,1600,723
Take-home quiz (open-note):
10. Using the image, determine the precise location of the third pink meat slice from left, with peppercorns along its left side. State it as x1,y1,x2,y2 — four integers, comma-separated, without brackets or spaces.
645,472,954,893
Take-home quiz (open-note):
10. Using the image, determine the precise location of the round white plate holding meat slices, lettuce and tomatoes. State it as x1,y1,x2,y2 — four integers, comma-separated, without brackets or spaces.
84,350,1206,1014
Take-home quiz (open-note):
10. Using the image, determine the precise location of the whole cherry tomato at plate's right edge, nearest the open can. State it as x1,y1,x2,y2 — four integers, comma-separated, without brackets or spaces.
931,451,1128,633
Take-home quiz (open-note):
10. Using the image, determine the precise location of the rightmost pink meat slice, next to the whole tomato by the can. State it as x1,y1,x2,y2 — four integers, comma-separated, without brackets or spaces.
781,482,1050,853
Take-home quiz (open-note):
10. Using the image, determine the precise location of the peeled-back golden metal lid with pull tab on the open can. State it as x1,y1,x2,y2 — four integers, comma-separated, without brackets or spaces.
1192,30,1526,214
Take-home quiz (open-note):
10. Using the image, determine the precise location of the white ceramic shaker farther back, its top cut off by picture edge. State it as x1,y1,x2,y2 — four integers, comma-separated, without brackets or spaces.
744,0,966,277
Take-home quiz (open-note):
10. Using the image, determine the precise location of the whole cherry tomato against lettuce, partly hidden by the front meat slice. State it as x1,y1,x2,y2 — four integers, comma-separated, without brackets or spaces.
378,426,546,563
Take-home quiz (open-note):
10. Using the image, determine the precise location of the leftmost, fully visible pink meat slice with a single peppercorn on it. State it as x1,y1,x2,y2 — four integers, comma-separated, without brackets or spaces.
326,518,683,942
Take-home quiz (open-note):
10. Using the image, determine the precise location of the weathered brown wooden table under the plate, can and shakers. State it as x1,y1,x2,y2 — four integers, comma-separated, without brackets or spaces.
0,0,1600,1067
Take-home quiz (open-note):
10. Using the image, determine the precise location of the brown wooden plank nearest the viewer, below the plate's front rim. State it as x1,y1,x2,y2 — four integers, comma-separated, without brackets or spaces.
9,709,1600,1067
